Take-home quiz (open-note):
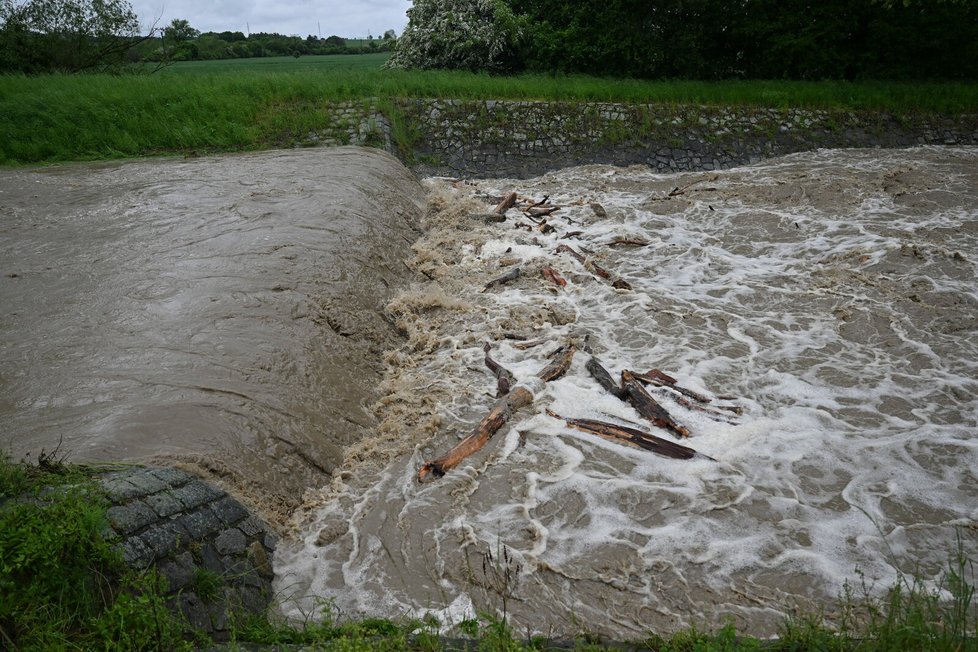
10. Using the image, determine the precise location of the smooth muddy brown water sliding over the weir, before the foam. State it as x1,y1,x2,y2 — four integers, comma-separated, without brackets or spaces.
0,148,423,512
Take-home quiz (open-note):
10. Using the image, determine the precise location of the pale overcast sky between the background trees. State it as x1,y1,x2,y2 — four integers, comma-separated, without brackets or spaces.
130,0,411,38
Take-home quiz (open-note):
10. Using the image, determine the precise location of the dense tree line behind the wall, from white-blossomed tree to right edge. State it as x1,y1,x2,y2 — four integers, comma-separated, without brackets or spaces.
391,0,978,80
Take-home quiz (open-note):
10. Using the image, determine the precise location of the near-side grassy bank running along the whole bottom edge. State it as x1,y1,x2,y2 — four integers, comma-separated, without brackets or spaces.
0,455,978,652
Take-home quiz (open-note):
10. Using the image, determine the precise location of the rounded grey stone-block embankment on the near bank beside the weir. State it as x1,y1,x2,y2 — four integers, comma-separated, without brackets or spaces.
99,467,275,639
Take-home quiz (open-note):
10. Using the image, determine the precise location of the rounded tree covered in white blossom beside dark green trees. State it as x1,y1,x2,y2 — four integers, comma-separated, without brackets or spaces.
387,0,521,72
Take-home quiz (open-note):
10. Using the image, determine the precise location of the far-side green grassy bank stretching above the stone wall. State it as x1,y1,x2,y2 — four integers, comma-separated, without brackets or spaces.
0,54,978,166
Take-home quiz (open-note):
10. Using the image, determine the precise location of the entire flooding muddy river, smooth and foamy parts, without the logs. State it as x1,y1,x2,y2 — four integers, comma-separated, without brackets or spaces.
0,148,978,638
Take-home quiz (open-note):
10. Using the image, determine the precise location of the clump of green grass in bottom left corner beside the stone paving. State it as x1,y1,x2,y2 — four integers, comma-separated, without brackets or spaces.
0,453,184,651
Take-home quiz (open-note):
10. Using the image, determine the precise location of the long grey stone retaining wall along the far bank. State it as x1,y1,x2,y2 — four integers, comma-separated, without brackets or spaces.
309,99,978,178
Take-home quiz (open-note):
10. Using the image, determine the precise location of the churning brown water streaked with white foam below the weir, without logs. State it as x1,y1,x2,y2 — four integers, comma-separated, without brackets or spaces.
278,148,978,637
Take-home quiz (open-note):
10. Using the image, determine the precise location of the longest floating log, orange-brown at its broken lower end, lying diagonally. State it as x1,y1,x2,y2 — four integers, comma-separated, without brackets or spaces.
418,344,577,482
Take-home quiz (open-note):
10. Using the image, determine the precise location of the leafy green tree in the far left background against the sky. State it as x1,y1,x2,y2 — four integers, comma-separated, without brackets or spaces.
0,0,149,73
